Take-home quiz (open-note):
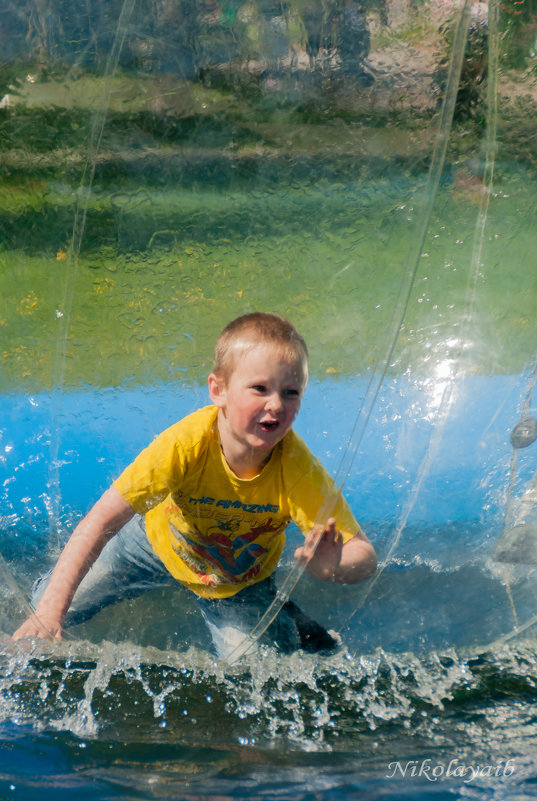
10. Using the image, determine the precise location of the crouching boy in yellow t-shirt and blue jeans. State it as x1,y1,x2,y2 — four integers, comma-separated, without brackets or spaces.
14,313,376,657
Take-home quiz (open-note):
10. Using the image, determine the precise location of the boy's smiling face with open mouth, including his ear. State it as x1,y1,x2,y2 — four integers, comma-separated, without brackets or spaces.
209,343,306,461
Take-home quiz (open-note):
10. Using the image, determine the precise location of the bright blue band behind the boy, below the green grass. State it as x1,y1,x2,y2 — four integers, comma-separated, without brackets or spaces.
0,375,533,536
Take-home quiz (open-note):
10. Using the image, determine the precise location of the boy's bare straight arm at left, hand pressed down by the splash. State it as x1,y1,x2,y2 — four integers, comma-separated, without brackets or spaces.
13,487,134,640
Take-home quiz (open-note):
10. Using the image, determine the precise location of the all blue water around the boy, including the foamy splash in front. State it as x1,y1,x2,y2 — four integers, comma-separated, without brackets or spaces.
0,376,537,801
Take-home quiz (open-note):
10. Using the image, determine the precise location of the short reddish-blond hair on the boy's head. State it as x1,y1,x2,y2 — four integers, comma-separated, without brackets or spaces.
213,312,308,383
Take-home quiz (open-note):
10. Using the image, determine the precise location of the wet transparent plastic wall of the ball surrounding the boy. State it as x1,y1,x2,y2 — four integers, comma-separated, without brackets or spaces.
2,2,535,657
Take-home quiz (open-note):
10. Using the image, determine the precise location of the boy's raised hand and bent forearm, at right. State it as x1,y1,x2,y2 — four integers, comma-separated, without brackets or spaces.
295,518,377,584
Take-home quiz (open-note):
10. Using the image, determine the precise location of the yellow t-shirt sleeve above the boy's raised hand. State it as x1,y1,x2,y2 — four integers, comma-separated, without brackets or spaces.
282,431,360,542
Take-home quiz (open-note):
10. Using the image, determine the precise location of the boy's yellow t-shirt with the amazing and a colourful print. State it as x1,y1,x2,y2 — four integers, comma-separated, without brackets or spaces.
114,406,359,598
